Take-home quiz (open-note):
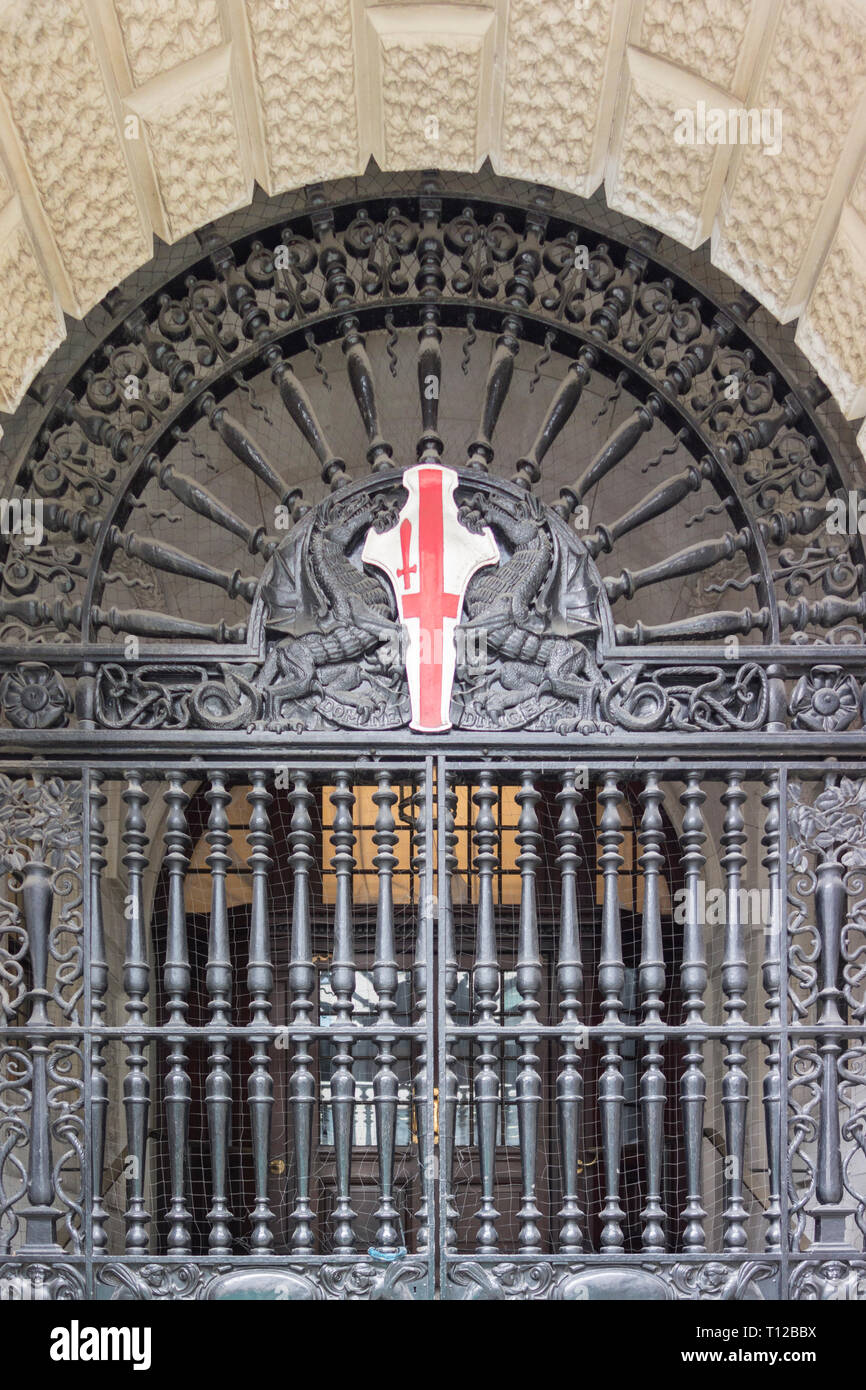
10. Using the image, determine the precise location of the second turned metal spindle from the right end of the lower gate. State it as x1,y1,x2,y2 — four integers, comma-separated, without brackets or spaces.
721,773,749,1250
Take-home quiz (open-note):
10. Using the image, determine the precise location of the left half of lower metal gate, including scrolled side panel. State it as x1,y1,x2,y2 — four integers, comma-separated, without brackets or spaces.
0,759,435,1300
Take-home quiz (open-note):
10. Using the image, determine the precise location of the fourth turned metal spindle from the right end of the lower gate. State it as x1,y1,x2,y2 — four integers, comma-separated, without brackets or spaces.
638,773,666,1254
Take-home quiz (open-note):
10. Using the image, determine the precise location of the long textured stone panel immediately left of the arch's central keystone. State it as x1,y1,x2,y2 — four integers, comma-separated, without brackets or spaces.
246,0,360,193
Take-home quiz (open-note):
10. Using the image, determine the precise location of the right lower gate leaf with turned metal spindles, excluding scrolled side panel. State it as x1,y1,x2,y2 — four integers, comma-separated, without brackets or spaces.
439,759,789,1300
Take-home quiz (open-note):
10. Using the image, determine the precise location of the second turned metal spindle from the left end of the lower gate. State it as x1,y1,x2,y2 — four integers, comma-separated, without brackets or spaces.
122,773,150,1252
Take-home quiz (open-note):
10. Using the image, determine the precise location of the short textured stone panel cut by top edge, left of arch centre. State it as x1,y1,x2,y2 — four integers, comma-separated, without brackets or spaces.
114,0,222,86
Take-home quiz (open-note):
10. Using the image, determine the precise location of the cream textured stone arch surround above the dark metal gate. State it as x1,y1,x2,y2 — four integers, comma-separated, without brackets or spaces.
0,0,866,469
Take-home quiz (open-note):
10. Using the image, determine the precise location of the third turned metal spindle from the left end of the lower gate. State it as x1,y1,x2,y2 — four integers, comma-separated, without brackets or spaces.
163,773,192,1254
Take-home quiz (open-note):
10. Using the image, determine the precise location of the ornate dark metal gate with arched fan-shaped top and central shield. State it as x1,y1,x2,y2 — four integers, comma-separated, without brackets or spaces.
0,177,866,1300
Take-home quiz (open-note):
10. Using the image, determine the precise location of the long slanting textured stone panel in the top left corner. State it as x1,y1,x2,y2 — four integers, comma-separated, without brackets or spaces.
0,0,150,315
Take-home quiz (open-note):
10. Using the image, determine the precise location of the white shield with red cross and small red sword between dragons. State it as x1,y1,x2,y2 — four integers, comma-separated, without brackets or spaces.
363,461,499,734
